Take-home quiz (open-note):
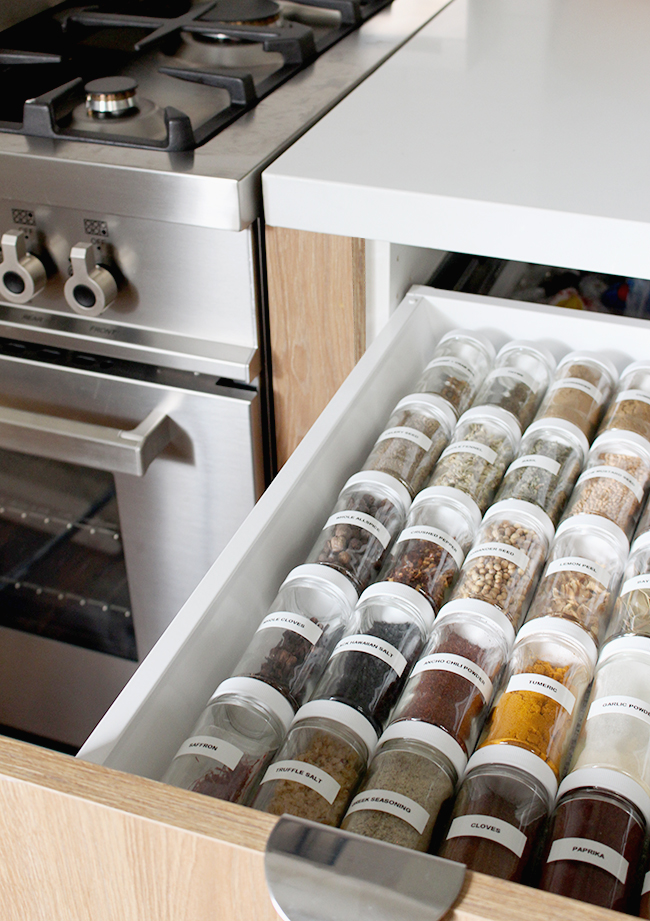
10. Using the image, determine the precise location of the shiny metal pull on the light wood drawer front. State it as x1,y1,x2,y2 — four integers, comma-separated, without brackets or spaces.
265,815,465,921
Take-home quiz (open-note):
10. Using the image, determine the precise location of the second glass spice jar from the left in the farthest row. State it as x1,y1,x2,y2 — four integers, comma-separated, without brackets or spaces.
474,339,555,432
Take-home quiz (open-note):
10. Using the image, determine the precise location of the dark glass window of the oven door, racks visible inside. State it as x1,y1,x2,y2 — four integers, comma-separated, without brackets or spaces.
0,450,137,660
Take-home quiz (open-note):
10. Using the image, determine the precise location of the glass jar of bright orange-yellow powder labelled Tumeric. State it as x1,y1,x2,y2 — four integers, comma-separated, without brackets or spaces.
481,617,597,778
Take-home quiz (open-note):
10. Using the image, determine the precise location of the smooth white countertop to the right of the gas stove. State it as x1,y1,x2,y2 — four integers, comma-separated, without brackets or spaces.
263,0,650,278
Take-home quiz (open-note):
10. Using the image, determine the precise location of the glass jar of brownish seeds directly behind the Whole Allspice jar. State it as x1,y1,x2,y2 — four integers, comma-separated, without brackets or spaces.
362,393,456,496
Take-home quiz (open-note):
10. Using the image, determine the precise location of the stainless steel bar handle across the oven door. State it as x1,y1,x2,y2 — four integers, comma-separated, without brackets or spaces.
0,406,171,476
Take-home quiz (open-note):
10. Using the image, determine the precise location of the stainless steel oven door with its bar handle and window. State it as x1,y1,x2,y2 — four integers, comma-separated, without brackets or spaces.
0,343,262,745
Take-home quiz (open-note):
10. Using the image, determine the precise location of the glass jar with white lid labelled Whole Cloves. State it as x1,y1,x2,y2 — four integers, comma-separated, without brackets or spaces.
233,563,358,710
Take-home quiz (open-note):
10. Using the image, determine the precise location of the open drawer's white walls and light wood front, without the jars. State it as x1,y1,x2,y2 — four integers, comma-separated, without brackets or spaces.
0,287,650,921
